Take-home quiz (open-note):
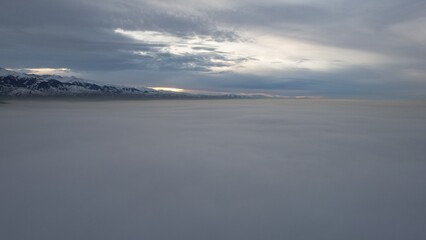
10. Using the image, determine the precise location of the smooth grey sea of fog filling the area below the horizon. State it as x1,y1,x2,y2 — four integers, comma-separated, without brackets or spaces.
0,100,426,240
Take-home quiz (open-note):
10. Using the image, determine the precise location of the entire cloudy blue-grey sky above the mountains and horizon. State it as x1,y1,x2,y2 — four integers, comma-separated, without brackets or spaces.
0,0,426,98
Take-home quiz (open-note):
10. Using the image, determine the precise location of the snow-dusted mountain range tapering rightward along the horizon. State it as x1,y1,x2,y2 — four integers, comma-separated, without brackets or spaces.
0,68,270,98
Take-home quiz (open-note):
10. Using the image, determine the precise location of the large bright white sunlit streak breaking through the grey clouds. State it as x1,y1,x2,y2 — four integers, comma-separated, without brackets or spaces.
115,29,388,74
